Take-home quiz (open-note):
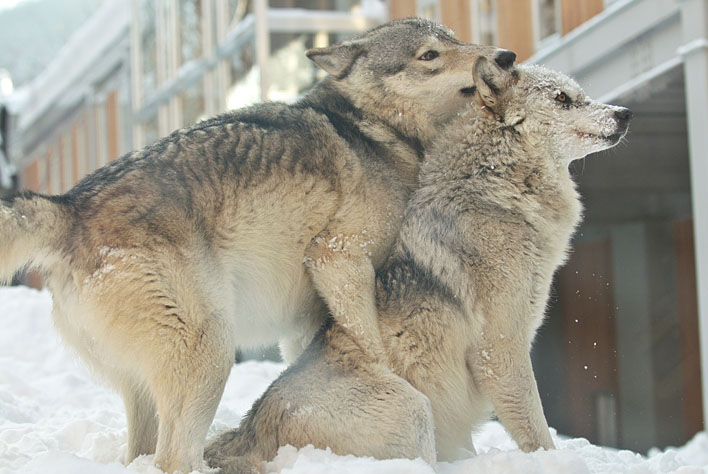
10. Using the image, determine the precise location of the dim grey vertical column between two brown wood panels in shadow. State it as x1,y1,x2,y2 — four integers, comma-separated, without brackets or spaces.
611,224,656,451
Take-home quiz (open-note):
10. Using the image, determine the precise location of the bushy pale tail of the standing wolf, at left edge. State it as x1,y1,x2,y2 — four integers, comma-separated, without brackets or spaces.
0,193,67,284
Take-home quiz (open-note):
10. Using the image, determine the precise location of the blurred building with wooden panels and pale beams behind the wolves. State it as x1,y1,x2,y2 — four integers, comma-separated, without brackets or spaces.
0,0,708,451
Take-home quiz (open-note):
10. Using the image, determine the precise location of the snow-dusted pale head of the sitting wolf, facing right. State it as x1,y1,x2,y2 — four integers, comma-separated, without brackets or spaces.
475,60,632,164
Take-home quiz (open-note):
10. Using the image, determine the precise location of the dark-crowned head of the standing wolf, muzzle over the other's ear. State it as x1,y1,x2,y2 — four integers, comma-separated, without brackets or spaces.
307,19,516,139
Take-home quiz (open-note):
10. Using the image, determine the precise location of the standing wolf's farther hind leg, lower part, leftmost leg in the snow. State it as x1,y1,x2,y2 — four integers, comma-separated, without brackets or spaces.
122,382,157,464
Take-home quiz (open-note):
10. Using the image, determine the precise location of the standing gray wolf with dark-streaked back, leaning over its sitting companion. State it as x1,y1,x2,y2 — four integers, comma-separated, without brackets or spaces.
0,19,515,472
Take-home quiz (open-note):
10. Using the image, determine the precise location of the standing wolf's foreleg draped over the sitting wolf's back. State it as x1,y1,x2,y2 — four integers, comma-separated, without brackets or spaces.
305,232,387,362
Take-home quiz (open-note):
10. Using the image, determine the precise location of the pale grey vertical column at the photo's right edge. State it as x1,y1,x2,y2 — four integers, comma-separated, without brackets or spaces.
678,0,708,426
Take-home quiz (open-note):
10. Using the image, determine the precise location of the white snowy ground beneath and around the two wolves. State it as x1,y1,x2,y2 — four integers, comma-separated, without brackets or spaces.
0,288,708,474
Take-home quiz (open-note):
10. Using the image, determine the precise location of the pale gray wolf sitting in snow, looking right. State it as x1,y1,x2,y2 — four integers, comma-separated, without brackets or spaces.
206,59,631,473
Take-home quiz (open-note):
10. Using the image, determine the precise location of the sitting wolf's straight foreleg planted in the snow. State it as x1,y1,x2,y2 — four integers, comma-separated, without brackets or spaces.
468,332,555,452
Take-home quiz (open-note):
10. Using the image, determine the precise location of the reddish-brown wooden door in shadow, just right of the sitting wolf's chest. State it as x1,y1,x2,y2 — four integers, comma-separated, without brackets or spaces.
558,240,620,445
